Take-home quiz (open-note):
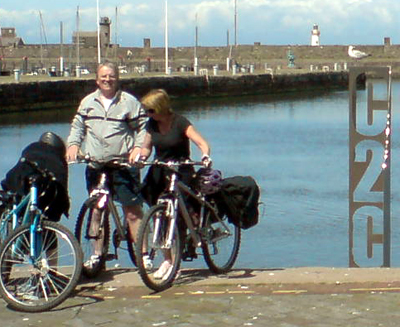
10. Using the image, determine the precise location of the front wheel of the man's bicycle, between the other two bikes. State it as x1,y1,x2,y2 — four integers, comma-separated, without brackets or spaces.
75,198,110,278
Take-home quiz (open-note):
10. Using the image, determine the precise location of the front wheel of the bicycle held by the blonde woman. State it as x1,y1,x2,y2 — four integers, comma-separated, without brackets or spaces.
136,204,182,292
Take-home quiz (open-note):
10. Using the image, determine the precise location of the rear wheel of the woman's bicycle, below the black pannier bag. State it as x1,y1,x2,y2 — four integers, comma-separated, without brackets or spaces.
201,210,240,274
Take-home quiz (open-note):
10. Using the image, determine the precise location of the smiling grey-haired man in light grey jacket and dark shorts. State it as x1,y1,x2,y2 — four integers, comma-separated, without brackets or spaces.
67,62,147,266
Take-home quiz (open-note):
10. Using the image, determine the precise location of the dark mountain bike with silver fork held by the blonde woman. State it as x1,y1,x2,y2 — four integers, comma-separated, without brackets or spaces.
136,161,241,291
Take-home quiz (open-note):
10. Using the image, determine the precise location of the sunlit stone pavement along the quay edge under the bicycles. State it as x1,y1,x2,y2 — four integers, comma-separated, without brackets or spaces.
0,267,400,327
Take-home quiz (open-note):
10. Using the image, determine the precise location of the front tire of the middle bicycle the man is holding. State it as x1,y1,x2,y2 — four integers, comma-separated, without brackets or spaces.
75,198,110,278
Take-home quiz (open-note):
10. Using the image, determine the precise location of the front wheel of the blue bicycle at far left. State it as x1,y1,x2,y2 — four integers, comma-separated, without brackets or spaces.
0,221,82,312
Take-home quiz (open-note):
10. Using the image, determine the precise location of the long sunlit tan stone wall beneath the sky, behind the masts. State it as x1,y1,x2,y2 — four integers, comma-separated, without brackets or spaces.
0,44,400,73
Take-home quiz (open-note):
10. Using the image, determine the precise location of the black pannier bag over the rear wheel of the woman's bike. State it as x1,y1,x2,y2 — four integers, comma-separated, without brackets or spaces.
212,176,260,229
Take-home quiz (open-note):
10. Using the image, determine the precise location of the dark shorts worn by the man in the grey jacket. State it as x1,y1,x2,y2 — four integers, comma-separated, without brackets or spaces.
86,166,143,206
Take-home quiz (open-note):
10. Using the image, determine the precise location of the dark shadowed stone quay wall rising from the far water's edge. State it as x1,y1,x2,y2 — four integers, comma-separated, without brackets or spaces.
0,71,348,113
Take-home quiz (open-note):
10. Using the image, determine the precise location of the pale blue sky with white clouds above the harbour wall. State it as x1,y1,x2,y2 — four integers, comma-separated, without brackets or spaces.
0,0,400,47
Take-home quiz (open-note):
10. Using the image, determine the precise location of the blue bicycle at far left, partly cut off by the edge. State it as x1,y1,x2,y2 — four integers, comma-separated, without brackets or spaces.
0,158,83,312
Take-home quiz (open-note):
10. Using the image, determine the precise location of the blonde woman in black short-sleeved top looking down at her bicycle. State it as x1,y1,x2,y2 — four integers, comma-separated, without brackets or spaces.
139,89,211,279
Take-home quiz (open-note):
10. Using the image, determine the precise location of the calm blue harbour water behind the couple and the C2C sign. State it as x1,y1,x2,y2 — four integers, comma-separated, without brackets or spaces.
0,83,400,268
